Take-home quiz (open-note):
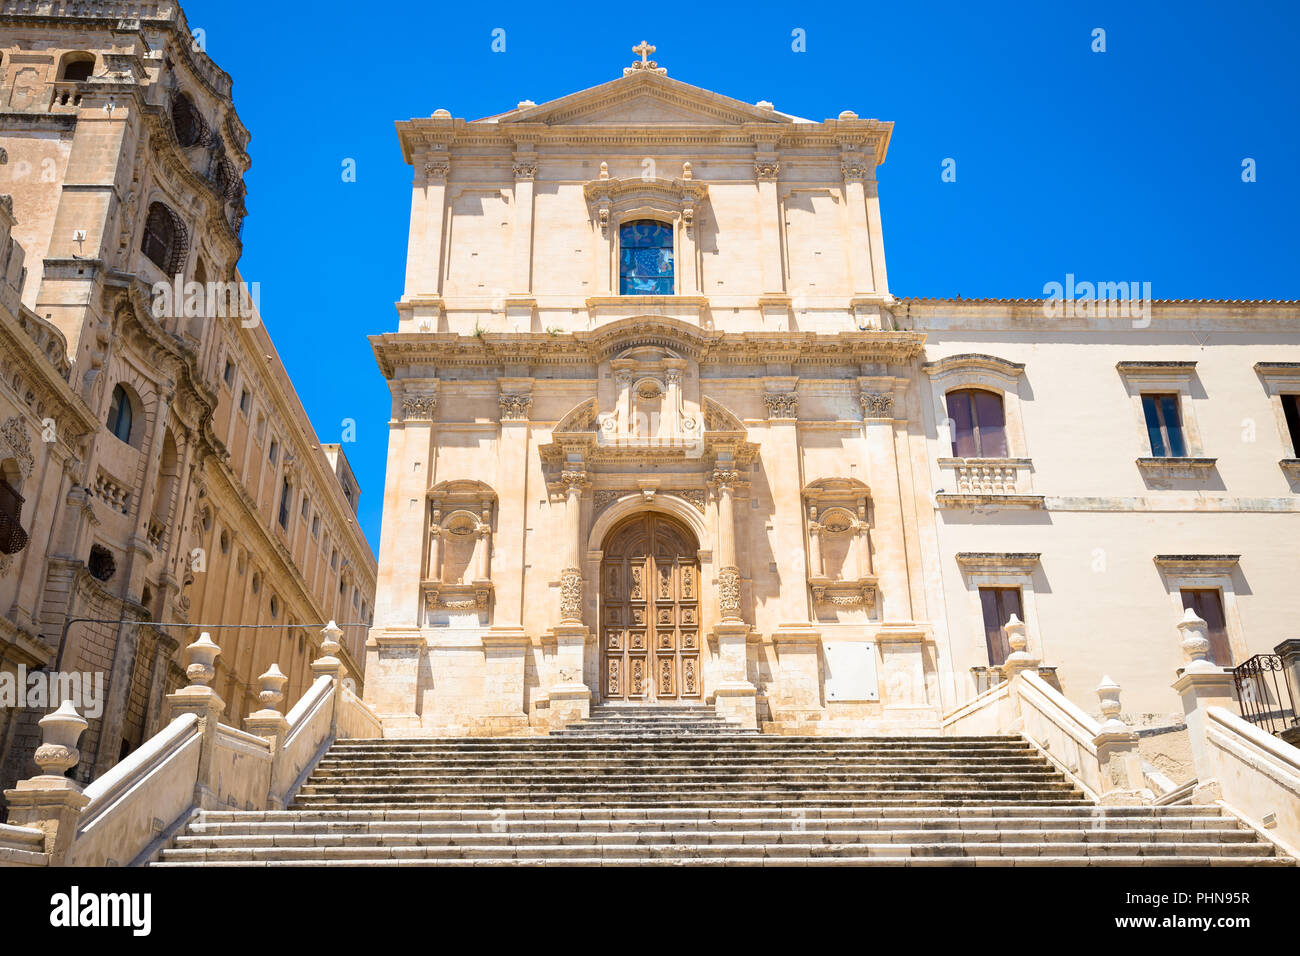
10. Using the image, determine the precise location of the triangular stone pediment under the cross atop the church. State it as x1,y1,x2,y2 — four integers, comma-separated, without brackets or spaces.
478,73,800,126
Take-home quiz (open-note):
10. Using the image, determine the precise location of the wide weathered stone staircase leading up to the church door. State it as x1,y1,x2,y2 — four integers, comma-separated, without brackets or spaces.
153,705,1294,866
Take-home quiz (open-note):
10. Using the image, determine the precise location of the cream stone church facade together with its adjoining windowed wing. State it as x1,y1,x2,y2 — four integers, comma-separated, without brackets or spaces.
365,43,1300,749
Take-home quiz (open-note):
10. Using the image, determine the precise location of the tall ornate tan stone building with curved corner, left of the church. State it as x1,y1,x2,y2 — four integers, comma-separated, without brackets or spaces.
0,0,376,786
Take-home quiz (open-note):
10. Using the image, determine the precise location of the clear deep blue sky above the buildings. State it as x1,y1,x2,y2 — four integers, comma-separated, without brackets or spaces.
183,0,1300,553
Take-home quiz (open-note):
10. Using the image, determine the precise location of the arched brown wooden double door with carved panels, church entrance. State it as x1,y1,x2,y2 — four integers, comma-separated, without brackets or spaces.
601,511,699,701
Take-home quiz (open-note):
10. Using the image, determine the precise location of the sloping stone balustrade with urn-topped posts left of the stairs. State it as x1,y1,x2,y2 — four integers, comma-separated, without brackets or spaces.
0,622,384,866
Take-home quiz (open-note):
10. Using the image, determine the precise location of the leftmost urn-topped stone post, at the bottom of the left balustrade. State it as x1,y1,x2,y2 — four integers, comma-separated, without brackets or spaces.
4,700,90,866
